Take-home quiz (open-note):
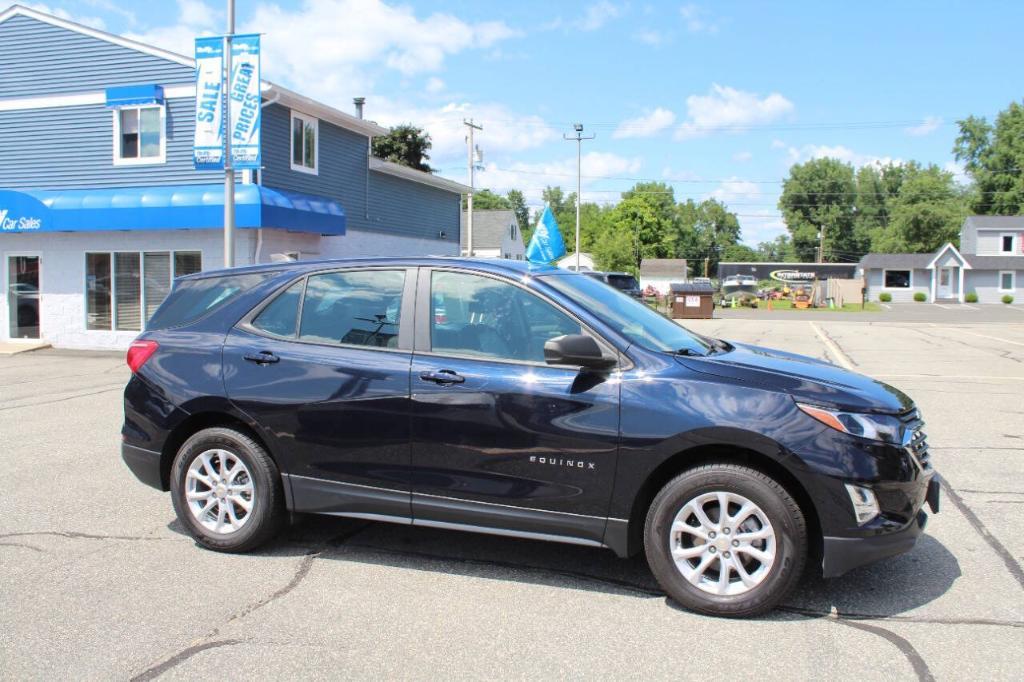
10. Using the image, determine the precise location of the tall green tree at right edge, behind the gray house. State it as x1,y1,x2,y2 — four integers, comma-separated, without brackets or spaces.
953,101,1024,215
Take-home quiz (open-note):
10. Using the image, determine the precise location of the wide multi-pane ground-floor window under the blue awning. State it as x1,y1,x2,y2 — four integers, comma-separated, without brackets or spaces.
85,251,203,332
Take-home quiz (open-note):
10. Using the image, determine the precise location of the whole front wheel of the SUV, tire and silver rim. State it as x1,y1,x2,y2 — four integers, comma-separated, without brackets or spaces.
644,464,807,616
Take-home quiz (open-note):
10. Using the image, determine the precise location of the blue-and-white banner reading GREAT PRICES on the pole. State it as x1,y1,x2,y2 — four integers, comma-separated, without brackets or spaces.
228,34,260,170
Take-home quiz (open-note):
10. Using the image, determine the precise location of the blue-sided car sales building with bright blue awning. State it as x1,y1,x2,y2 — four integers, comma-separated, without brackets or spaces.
0,6,467,348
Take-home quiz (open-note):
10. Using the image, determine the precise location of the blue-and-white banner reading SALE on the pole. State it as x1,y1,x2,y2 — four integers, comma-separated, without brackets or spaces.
193,37,224,170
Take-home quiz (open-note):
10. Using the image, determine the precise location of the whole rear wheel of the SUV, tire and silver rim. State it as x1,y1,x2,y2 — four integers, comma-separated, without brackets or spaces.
171,427,285,552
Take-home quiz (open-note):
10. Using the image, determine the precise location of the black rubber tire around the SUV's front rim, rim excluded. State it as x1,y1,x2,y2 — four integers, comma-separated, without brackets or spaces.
644,463,807,617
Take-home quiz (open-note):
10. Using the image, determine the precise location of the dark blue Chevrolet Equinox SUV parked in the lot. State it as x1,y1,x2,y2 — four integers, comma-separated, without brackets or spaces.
123,258,938,615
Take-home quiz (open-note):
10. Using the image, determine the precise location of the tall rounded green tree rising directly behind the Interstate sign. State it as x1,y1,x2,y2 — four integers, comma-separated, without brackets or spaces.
778,159,867,262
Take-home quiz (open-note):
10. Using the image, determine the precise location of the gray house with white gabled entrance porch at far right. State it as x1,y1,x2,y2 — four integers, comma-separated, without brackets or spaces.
858,216,1024,305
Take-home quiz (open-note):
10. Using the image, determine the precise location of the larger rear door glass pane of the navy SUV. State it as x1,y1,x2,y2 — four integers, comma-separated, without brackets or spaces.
299,270,406,348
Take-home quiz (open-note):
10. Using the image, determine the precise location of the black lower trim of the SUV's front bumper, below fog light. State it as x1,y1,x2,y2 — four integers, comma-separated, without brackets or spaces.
821,476,939,578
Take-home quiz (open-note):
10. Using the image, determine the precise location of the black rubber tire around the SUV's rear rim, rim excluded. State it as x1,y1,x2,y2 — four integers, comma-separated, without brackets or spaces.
171,427,286,553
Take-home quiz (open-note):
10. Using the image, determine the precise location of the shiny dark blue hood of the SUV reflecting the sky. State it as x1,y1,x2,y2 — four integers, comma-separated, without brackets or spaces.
677,343,913,414
